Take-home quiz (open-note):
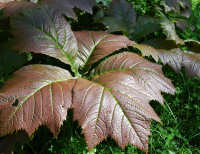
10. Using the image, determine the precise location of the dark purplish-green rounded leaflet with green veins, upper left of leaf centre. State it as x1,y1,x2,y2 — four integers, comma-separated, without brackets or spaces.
11,7,78,64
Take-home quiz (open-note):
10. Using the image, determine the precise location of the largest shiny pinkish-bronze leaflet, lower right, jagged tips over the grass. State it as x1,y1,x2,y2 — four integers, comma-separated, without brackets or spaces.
72,53,174,152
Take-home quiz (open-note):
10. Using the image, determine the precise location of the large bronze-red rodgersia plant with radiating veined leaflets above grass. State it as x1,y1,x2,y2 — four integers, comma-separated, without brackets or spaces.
0,0,200,152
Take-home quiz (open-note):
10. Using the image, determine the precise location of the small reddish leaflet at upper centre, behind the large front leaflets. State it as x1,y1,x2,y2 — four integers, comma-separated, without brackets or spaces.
74,31,133,69
